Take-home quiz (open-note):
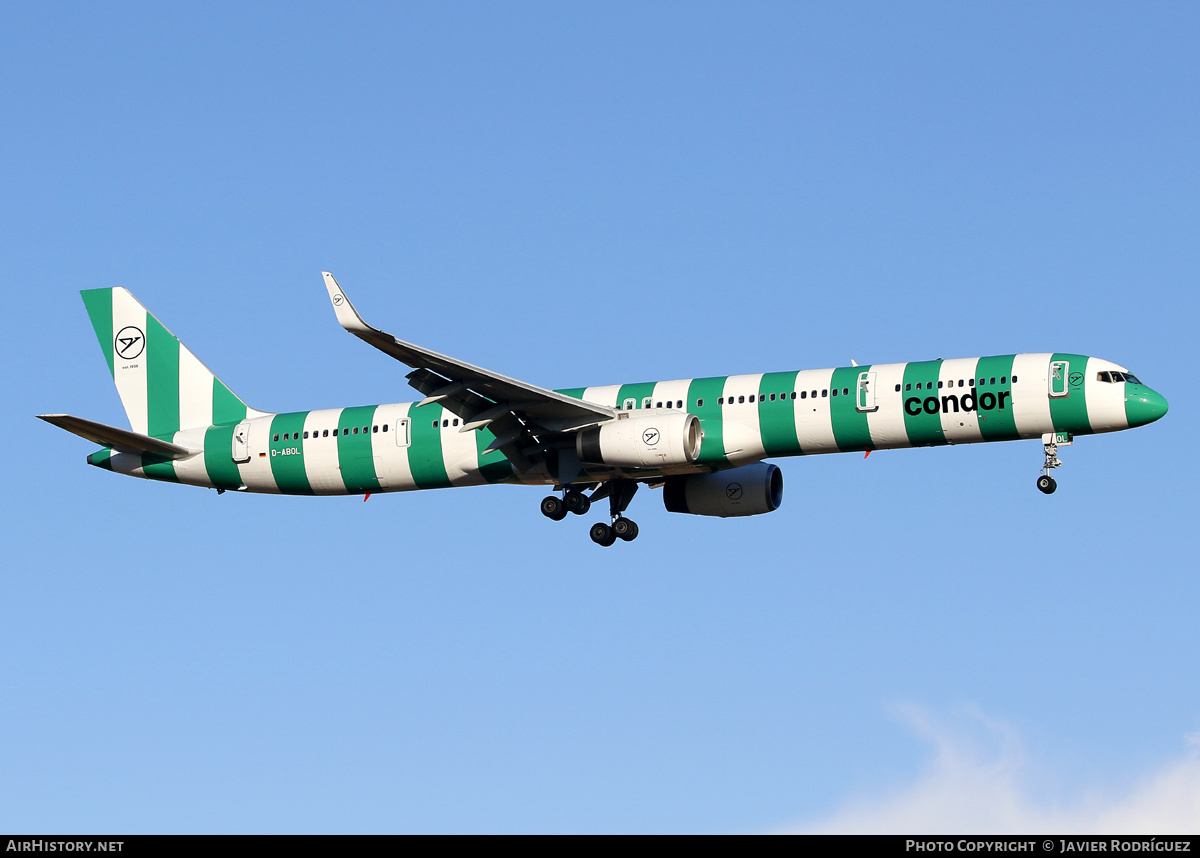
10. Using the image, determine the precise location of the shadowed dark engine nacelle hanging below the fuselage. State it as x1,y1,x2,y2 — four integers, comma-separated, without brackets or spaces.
662,462,784,518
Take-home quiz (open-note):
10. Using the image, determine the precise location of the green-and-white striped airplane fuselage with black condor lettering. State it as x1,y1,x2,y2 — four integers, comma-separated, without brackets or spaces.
89,353,1166,494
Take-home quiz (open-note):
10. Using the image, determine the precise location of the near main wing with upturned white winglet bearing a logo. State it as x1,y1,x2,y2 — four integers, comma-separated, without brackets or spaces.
322,271,617,472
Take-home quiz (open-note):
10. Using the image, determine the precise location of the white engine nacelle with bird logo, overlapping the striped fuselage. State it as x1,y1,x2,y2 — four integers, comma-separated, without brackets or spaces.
575,409,704,468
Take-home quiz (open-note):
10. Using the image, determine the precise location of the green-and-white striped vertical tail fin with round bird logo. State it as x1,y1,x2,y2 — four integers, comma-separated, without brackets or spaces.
80,287,260,437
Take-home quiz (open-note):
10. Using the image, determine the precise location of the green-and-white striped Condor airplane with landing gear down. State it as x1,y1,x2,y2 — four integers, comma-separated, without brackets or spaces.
37,271,1168,546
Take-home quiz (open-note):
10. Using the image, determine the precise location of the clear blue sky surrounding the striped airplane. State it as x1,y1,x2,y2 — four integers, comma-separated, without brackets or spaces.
0,4,1200,832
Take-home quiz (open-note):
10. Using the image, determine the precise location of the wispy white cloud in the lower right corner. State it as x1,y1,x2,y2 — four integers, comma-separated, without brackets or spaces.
784,706,1200,834
